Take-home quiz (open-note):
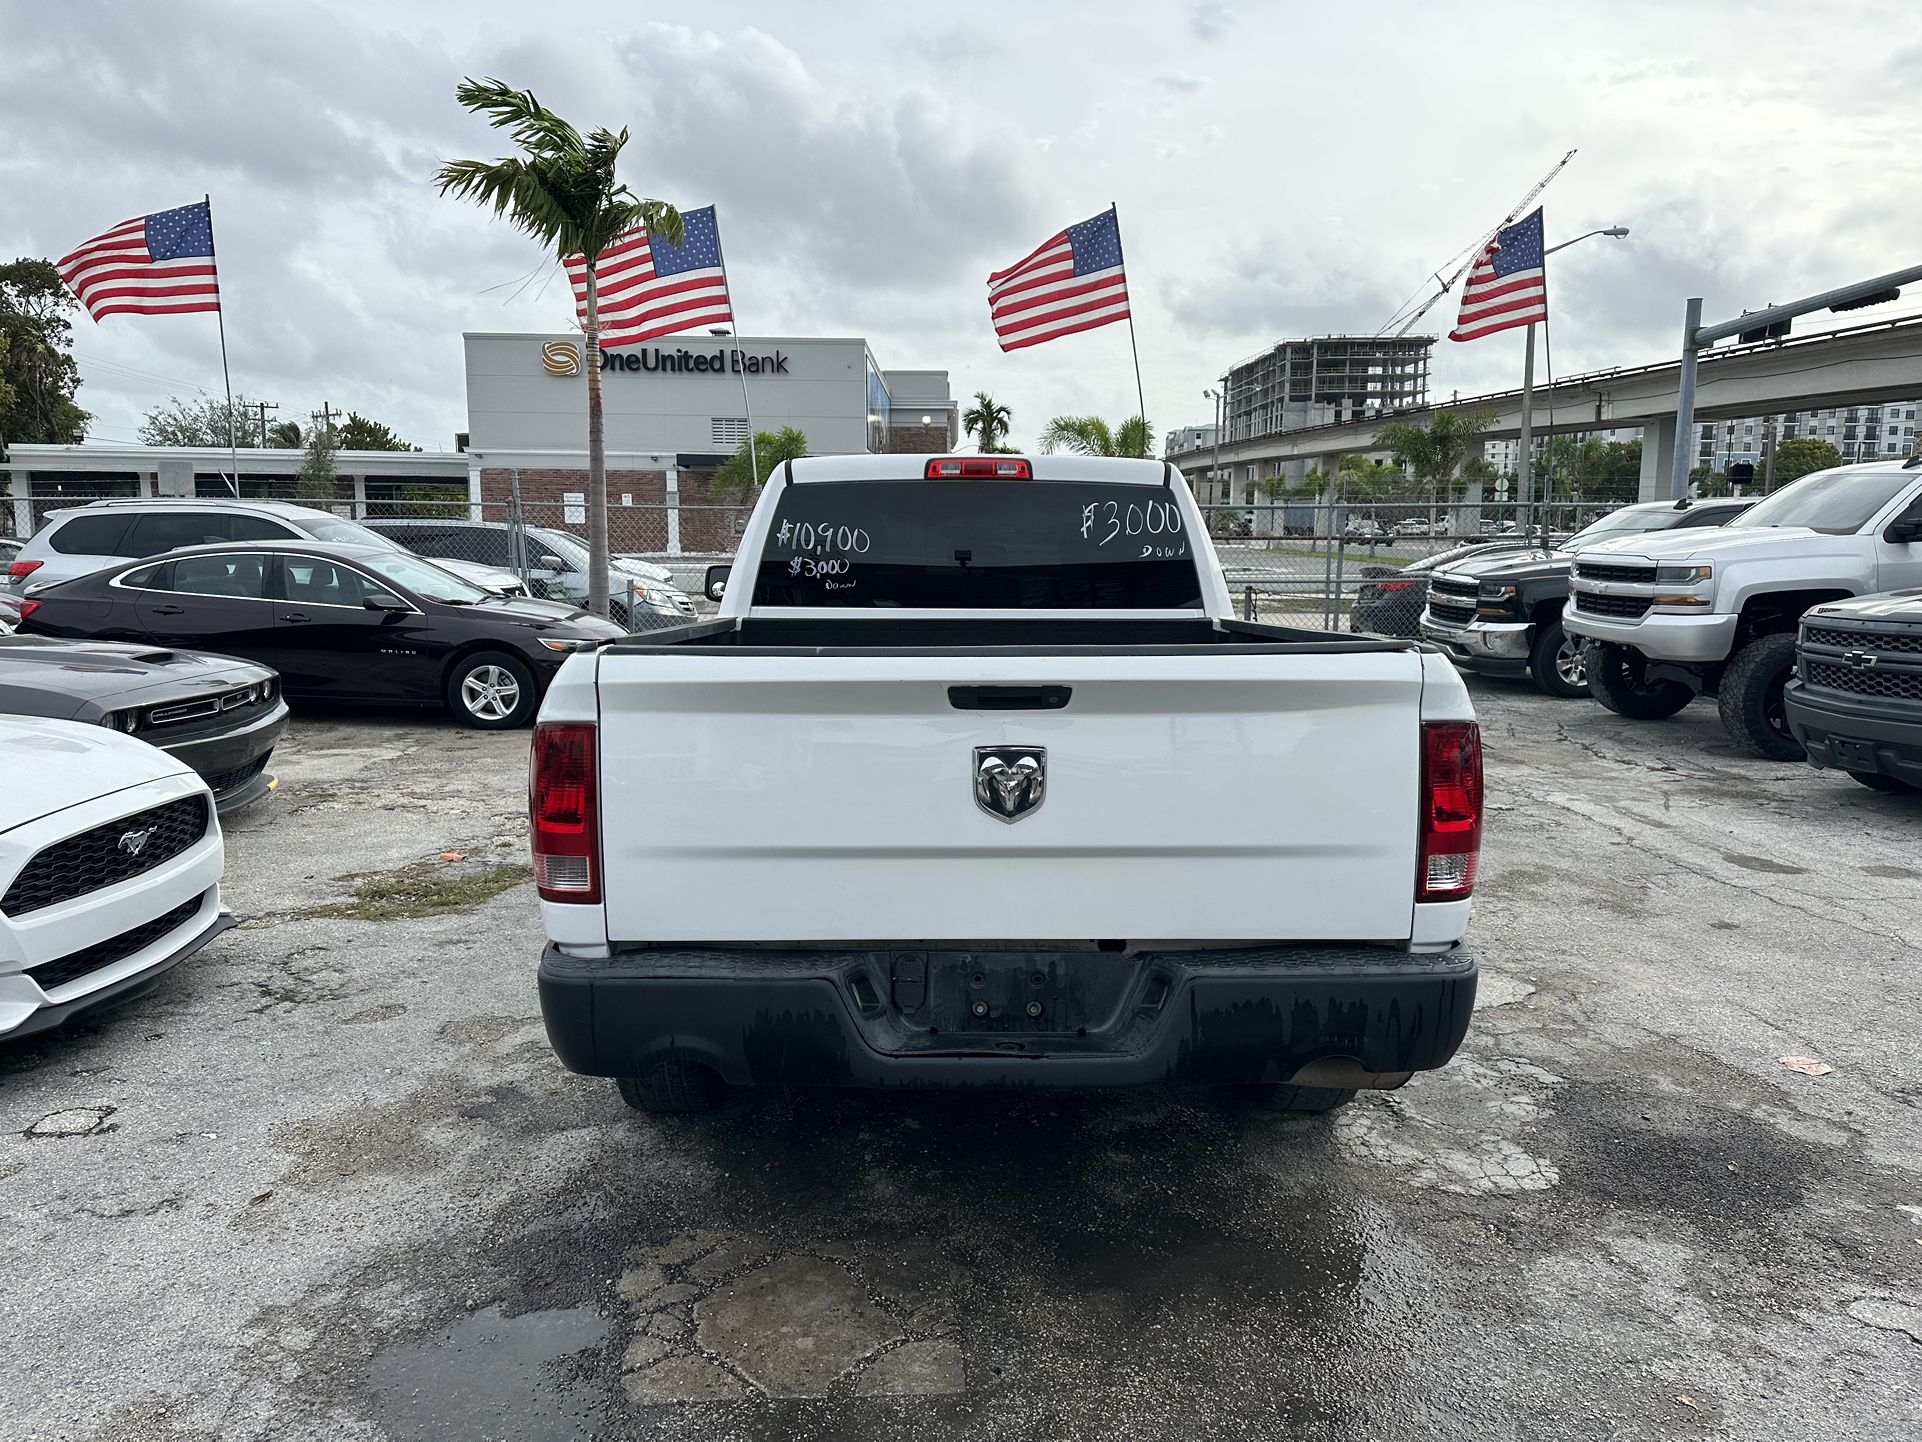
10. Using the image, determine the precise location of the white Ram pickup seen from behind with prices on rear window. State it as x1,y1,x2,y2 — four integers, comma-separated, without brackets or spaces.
530,456,1482,1111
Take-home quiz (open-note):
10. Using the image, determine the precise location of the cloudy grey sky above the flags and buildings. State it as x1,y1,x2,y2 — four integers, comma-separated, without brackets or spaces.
0,0,1922,450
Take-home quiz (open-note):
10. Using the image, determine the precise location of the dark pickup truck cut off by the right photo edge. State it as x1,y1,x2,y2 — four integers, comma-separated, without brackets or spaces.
1782,590,1922,796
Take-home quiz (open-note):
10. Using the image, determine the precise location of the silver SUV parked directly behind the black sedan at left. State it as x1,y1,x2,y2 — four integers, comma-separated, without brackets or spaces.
6,496,527,596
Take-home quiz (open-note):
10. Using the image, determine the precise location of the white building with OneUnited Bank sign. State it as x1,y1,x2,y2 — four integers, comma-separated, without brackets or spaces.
463,333,957,552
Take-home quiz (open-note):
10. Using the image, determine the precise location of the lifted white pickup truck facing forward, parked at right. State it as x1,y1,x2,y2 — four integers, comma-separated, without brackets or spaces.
1563,458,1922,761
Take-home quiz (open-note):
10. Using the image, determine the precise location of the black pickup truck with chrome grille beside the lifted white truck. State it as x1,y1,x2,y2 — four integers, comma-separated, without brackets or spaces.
1422,500,1753,700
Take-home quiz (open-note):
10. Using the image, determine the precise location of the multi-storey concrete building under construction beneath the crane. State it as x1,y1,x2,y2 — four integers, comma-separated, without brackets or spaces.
1222,335,1436,442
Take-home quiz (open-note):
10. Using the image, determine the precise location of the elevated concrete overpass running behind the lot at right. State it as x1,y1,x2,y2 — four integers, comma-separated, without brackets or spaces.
1167,317,1922,500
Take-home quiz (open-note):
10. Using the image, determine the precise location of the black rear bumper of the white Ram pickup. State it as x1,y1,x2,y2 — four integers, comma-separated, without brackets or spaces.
540,944,1476,1086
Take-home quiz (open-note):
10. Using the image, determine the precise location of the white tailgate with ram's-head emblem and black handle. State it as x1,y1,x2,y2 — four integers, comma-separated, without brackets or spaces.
598,648,1422,942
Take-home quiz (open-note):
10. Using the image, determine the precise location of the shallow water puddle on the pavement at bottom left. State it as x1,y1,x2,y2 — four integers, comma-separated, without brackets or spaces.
369,1305,607,1442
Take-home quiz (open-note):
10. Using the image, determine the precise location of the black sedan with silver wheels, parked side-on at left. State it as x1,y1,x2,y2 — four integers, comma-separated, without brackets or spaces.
19,540,627,731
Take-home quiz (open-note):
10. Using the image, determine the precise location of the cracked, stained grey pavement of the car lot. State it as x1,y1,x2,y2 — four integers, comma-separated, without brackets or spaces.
0,684,1922,1442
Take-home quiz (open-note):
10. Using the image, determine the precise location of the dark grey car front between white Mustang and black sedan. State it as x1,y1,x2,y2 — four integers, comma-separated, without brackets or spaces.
0,636,286,813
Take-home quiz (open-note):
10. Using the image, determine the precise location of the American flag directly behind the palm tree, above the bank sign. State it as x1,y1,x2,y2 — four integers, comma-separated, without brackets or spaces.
567,206,734,346
